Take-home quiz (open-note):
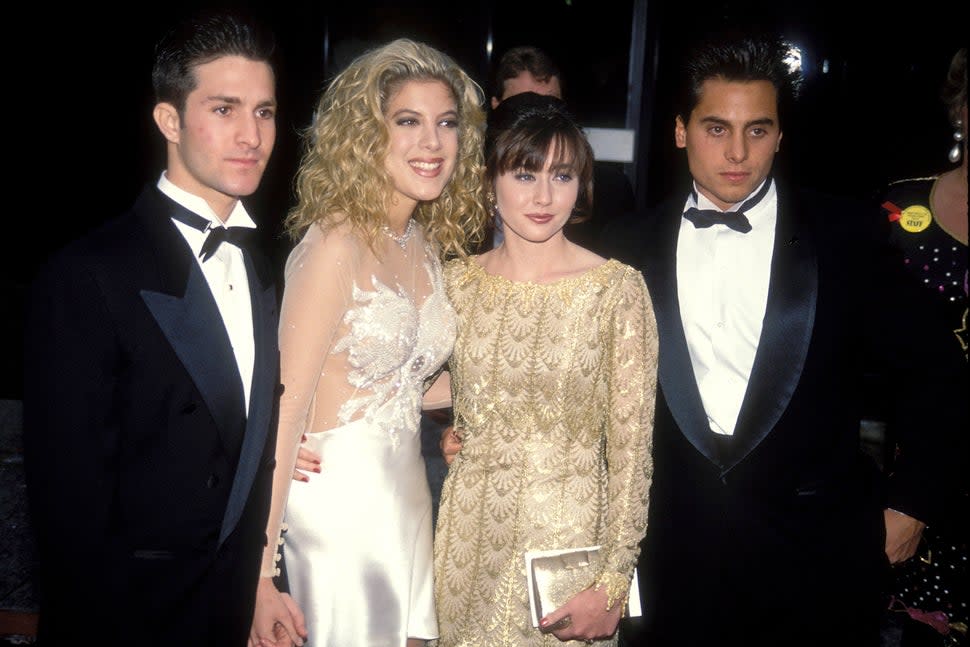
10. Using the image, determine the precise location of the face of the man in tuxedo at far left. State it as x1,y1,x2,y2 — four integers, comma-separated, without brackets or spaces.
155,56,276,215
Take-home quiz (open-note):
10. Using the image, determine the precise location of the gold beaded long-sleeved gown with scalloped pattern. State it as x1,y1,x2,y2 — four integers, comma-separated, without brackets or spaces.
433,258,657,647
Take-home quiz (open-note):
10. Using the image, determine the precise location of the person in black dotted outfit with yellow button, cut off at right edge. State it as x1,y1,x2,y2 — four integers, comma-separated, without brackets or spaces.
880,47,970,647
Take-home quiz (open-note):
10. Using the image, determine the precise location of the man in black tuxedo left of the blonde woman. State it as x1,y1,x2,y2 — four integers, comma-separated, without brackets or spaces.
24,8,280,647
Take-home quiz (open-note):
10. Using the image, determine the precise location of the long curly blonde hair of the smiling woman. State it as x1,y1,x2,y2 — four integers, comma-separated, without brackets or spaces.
285,38,488,257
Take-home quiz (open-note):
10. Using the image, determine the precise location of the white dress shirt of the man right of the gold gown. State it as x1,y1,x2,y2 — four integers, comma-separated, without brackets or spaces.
677,180,778,435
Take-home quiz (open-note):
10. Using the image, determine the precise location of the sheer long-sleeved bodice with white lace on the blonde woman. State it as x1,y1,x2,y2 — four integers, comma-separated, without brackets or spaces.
263,220,455,575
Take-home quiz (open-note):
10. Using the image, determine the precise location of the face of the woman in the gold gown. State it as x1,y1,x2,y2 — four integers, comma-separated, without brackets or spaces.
495,143,579,243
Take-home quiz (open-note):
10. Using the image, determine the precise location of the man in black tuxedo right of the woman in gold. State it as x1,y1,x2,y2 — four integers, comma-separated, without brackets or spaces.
605,31,967,647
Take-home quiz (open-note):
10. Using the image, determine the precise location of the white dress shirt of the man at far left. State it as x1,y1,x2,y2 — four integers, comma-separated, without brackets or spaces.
158,172,256,415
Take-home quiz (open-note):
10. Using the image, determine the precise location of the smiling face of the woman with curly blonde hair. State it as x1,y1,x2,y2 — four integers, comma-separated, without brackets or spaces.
384,81,458,211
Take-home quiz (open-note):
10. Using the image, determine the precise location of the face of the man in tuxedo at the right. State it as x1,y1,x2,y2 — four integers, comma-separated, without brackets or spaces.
674,79,782,209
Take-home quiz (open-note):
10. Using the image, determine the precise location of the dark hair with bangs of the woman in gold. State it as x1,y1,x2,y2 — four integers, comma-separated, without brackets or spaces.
485,92,593,223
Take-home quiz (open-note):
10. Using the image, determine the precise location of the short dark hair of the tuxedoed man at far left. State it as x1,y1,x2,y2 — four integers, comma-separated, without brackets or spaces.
152,10,276,116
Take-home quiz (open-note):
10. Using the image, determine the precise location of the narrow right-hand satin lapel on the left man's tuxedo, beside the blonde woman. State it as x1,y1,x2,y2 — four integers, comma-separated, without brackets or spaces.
219,252,279,544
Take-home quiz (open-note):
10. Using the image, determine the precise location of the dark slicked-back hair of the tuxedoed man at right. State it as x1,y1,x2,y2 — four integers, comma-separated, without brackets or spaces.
676,32,802,124
